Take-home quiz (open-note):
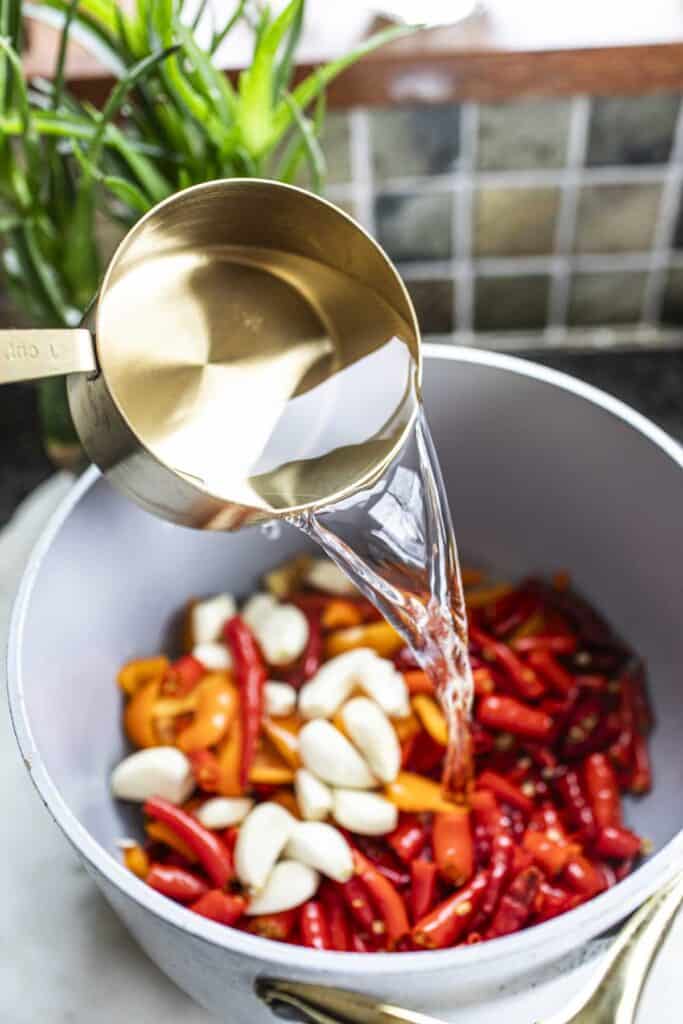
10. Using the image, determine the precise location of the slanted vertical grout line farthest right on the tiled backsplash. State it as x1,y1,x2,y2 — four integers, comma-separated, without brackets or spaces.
642,95,683,324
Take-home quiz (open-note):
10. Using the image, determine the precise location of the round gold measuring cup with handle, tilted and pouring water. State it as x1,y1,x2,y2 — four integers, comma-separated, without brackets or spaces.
0,179,421,529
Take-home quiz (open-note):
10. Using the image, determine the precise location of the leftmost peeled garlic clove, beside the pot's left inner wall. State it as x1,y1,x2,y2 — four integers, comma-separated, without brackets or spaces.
112,746,195,804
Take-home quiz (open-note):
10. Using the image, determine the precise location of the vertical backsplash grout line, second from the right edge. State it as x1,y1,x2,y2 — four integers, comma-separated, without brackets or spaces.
548,96,591,327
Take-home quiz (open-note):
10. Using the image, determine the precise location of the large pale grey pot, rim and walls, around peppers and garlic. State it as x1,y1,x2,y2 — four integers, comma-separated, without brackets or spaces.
9,346,683,1024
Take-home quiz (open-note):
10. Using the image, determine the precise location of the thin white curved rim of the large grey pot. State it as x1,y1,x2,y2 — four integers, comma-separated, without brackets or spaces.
7,344,683,984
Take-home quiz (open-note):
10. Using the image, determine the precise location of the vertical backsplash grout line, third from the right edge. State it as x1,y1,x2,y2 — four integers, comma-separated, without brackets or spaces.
453,102,479,332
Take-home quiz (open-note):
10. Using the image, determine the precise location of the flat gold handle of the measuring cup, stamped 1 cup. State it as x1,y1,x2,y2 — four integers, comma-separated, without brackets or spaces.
0,328,97,384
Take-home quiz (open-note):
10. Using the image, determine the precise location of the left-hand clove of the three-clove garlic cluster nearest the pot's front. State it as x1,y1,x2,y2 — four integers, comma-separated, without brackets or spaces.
234,801,296,890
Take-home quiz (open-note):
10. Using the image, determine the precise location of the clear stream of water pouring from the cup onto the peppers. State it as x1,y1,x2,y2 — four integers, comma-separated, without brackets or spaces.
290,399,473,801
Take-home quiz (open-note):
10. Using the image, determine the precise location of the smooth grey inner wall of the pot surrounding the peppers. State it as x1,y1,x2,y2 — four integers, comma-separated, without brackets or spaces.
13,353,683,880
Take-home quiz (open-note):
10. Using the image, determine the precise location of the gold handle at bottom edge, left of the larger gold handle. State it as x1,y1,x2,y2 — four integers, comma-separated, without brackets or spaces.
256,978,443,1024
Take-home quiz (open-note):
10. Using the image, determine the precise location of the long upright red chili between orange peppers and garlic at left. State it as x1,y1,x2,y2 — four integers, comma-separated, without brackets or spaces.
223,615,267,786
